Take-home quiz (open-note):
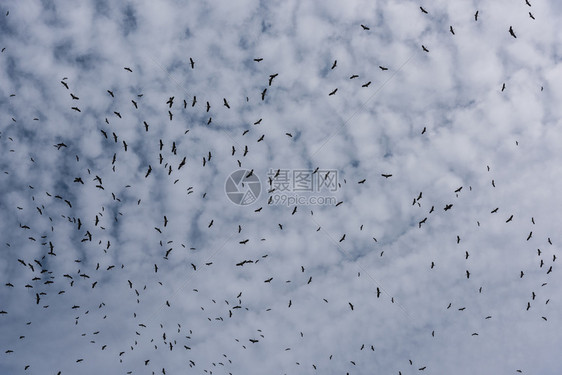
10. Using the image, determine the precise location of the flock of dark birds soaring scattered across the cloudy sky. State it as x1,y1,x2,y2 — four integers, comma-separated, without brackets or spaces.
0,0,557,375
